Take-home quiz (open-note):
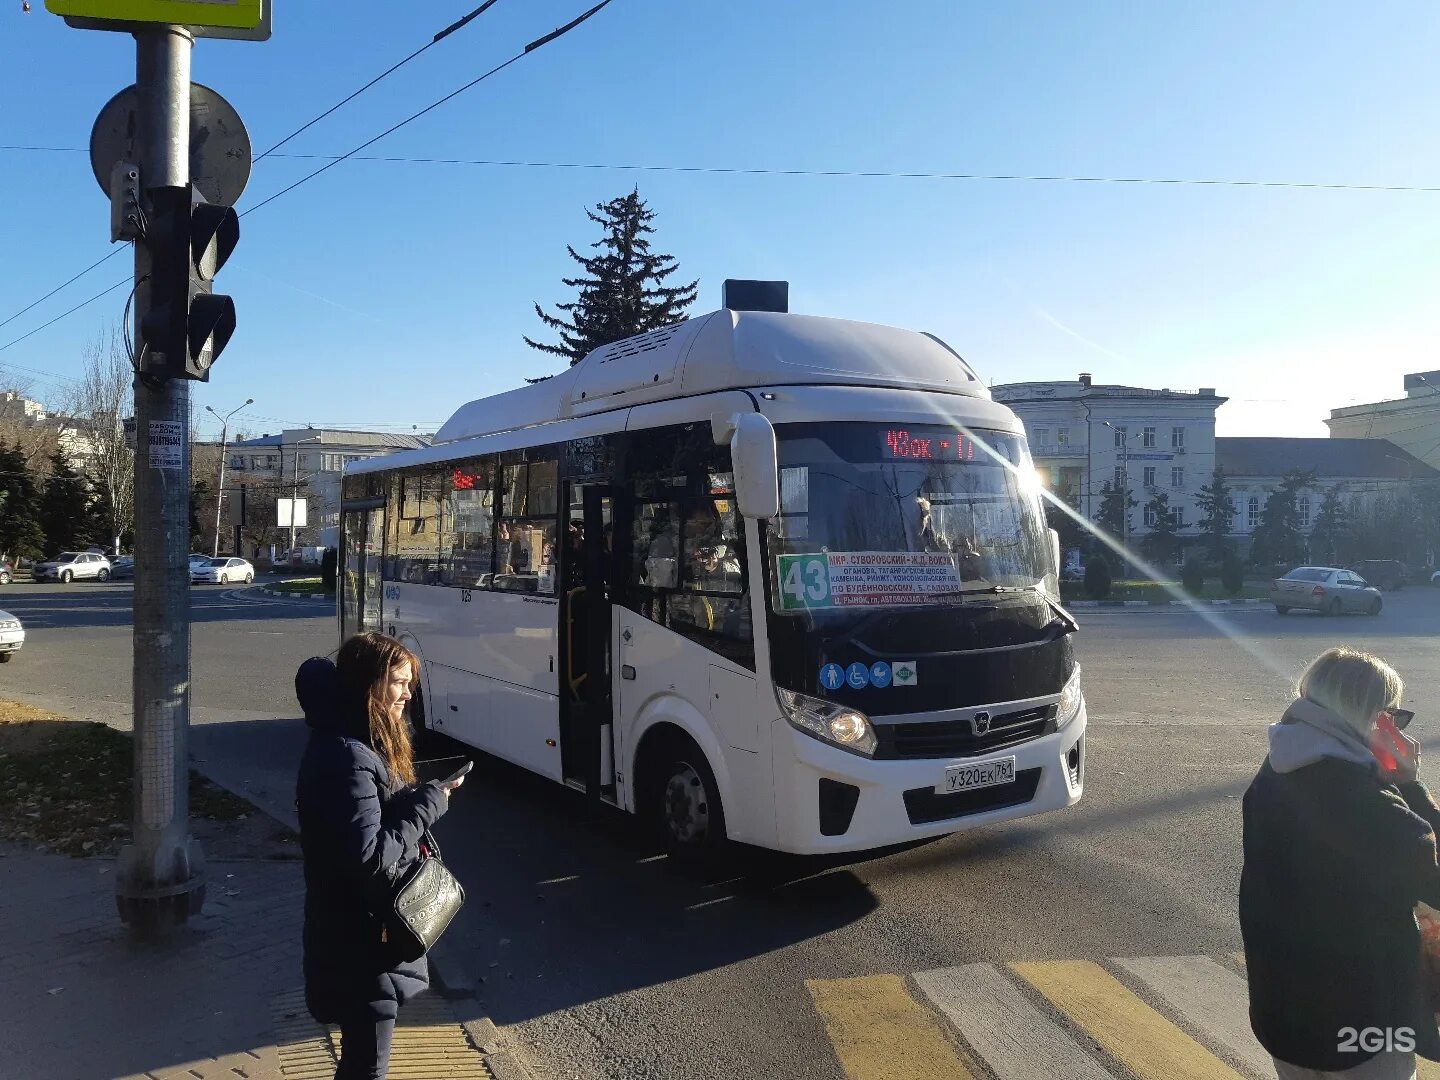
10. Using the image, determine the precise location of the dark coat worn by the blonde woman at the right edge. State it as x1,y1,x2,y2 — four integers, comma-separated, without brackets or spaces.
1240,757,1440,1071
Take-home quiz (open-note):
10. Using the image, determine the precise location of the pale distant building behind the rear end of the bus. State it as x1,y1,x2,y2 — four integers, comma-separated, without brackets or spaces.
225,428,431,547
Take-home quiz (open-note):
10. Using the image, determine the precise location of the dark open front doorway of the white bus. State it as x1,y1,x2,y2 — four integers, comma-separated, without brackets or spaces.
560,484,616,802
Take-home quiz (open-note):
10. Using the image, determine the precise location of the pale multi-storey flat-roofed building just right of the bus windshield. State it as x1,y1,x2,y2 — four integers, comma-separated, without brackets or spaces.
991,374,1225,536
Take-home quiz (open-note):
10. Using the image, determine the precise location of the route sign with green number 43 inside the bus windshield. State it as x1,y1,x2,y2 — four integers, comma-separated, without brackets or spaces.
775,552,960,611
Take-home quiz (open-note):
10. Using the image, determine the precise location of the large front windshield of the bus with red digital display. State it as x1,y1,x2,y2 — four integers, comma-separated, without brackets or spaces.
769,423,1050,615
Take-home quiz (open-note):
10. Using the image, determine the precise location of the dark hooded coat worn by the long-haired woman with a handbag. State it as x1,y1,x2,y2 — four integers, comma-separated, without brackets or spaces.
295,658,448,1024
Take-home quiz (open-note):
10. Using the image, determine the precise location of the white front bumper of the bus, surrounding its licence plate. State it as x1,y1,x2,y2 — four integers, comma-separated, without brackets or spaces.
770,703,1087,854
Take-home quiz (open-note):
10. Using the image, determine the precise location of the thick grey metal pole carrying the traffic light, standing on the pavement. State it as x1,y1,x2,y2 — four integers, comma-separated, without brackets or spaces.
115,26,204,930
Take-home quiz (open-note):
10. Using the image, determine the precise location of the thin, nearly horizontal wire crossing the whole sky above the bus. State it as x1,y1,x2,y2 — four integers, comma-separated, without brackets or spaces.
8,140,1440,194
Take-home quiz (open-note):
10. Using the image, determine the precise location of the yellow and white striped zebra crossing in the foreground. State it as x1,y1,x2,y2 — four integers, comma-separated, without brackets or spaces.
805,953,1440,1080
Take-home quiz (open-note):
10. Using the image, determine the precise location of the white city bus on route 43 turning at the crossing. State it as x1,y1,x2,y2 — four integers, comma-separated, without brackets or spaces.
340,302,1086,854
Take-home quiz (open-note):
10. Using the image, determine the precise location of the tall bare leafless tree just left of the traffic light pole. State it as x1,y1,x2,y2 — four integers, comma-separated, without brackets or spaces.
68,327,135,547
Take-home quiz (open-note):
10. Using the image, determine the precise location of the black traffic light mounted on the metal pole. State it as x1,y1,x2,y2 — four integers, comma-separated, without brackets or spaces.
140,187,240,382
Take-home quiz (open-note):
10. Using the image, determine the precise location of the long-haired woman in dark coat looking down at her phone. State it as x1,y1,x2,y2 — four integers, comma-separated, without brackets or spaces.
295,634,464,1080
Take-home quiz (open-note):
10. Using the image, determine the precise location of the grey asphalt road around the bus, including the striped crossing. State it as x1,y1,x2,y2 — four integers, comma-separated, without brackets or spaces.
0,586,1440,1080
